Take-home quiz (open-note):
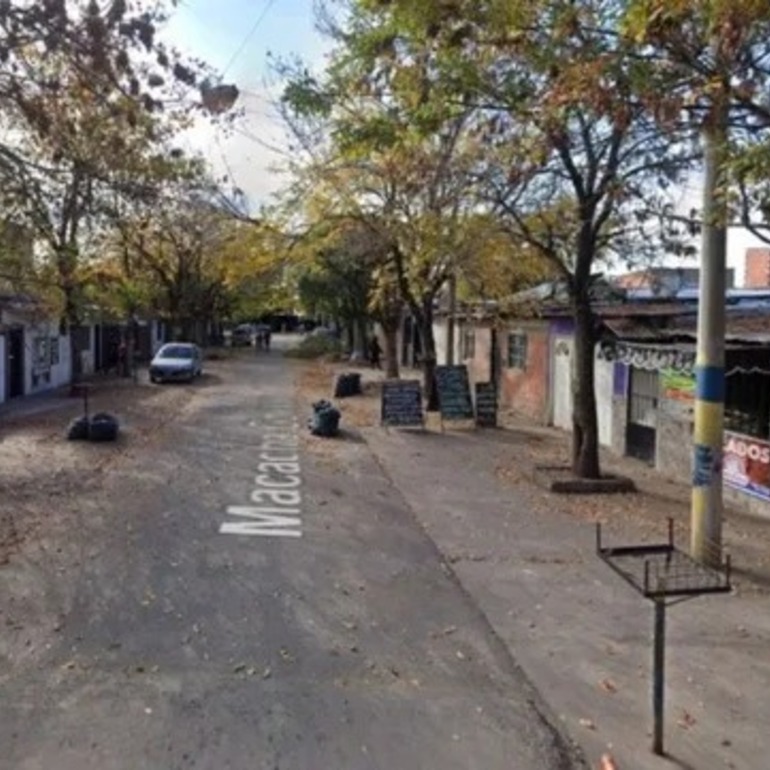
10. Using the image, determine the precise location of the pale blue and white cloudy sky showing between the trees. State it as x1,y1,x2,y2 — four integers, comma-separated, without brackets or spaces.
163,0,762,286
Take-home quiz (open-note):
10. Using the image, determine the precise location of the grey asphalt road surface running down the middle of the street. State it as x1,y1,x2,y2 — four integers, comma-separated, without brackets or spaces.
0,344,573,770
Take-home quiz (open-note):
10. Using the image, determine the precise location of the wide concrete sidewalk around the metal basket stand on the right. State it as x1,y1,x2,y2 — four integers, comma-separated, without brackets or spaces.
362,428,770,770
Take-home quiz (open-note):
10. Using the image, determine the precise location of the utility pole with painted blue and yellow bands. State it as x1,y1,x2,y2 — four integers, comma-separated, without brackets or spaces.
690,102,727,566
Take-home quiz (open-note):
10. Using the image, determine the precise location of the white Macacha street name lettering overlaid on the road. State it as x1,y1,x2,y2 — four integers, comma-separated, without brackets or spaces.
219,407,302,537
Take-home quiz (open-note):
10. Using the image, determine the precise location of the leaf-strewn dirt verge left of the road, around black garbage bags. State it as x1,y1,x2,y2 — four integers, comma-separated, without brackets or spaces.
0,374,207,680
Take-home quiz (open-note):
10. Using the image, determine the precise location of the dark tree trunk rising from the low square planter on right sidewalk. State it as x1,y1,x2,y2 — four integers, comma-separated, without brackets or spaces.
572,288,601,479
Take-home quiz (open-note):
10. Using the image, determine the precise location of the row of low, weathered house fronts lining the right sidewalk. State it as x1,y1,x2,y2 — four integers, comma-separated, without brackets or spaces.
437,286,770,517
